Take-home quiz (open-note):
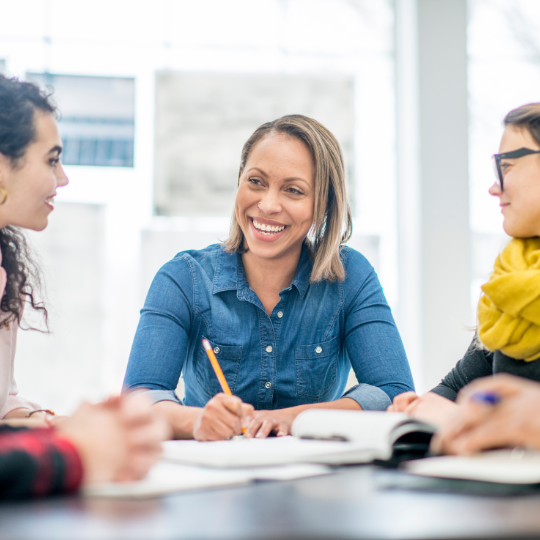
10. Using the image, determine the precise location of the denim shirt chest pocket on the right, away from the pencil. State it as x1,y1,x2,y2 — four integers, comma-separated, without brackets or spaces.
294,337,340,398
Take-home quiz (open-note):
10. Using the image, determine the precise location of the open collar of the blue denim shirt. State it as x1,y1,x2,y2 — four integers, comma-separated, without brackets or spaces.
212,244,313,297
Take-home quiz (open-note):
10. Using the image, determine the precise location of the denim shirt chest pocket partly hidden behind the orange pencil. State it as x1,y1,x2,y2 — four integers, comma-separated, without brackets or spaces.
195,338,242,396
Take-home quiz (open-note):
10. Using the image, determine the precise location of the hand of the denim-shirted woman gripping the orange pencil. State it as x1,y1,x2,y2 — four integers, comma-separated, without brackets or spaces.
193,393,254,441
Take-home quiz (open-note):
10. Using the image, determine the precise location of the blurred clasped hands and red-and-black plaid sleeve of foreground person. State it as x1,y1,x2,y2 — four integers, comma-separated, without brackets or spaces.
0,395,168,499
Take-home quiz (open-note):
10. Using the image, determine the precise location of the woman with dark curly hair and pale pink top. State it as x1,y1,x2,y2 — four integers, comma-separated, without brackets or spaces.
0,74,62,423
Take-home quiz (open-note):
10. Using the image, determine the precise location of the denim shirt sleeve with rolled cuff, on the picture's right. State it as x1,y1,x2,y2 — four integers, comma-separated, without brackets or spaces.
343,250,414,410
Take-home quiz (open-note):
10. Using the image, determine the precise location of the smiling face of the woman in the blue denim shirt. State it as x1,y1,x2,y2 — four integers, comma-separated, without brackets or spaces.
235,133,315,259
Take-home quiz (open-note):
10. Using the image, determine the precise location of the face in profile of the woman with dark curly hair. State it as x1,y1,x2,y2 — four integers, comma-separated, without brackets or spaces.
0,110,68,231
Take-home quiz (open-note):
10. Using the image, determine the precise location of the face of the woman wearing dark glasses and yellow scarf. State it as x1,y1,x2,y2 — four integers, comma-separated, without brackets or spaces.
489,125,540,238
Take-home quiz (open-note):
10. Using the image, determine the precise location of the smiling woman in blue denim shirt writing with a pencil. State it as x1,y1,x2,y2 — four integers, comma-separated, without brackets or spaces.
124,115,413,440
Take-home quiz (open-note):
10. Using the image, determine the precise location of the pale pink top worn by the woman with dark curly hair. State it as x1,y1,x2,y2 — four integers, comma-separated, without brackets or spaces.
0,252,41,419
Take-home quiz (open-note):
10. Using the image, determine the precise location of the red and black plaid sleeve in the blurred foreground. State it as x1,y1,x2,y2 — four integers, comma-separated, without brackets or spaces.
0,426,83,499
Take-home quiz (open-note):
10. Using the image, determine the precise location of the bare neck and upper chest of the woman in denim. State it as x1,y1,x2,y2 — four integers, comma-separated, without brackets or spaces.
242,246,302,294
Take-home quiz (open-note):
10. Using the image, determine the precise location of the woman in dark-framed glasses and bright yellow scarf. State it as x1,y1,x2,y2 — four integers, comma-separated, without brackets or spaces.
388,103,540,425
